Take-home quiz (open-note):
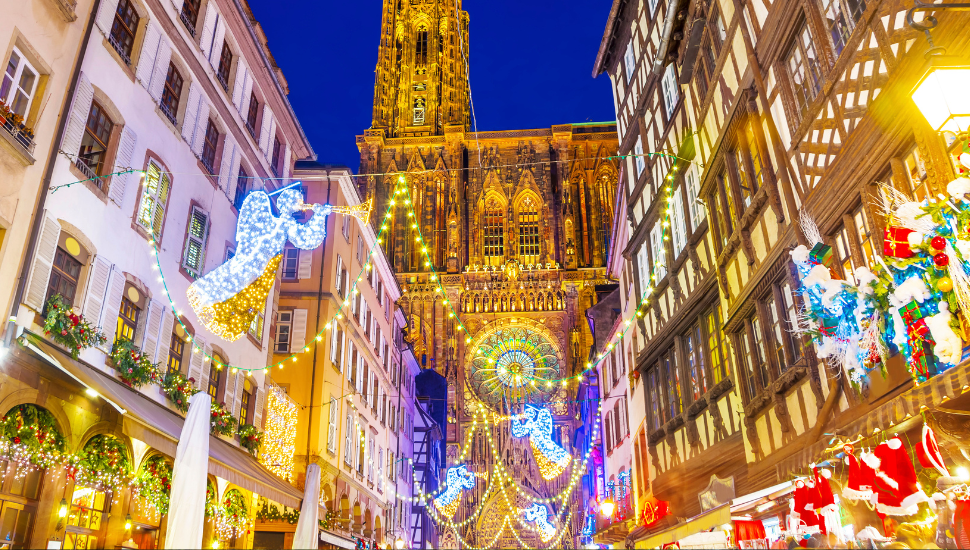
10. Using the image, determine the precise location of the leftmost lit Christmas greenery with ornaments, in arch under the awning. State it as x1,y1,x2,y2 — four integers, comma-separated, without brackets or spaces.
0,403,67,468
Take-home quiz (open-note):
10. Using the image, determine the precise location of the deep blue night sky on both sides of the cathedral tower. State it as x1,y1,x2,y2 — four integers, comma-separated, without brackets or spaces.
249,0,615,171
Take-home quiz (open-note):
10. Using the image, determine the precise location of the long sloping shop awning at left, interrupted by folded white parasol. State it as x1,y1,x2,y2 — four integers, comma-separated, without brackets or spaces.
26,338,303,508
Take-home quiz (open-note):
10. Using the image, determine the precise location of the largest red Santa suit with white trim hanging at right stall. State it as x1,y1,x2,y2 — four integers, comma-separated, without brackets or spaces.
863,437,930,516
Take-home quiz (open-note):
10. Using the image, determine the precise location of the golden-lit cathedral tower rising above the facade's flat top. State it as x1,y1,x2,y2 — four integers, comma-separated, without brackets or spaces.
371,0,469,137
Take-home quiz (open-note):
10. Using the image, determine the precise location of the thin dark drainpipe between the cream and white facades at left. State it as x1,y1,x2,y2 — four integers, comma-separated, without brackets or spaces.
3,0,101,348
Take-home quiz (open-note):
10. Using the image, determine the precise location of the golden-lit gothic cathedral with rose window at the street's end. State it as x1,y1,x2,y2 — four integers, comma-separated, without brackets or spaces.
357,0,619,548
